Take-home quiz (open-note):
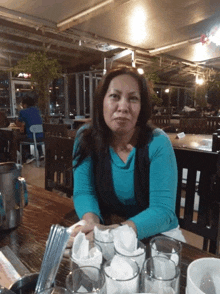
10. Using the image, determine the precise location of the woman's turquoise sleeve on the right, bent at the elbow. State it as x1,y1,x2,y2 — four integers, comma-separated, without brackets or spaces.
130,133,178,239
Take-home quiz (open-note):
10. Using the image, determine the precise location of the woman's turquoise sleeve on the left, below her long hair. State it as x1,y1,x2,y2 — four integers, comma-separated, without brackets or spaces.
73,133,101,219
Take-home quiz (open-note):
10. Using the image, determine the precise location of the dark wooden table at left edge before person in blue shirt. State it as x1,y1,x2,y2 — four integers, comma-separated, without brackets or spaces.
0,127,21,162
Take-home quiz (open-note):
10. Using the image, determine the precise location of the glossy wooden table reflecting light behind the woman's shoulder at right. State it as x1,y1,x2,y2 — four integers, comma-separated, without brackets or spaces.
167,133,212,151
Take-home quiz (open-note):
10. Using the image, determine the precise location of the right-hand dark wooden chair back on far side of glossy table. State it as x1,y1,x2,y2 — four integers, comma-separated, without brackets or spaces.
179,117,207,134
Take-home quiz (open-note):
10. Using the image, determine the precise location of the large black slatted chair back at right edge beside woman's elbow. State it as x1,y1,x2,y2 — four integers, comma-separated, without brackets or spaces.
174,149,220,254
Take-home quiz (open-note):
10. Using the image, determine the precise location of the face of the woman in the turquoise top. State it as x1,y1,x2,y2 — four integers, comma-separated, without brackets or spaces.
103,74,141,134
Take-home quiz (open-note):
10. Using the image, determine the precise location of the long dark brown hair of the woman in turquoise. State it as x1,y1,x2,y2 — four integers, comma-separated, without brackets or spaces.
74,67,152,166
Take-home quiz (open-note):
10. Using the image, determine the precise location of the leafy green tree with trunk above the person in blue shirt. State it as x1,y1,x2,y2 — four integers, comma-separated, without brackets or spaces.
12,52,61,115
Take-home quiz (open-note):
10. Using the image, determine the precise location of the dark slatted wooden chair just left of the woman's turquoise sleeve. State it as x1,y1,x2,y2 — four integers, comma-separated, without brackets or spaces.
45,136,74,197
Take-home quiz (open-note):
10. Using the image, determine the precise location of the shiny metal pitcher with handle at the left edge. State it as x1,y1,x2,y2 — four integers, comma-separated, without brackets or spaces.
0,162,28,230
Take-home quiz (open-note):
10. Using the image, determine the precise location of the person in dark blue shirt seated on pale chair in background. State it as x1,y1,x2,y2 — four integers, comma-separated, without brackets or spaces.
16,96,44,163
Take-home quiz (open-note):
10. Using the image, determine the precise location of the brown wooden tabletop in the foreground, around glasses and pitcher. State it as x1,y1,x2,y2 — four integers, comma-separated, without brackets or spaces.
0,185,217,294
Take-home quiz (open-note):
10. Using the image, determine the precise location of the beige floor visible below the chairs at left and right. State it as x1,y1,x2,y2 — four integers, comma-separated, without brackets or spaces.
22,161,203,248
